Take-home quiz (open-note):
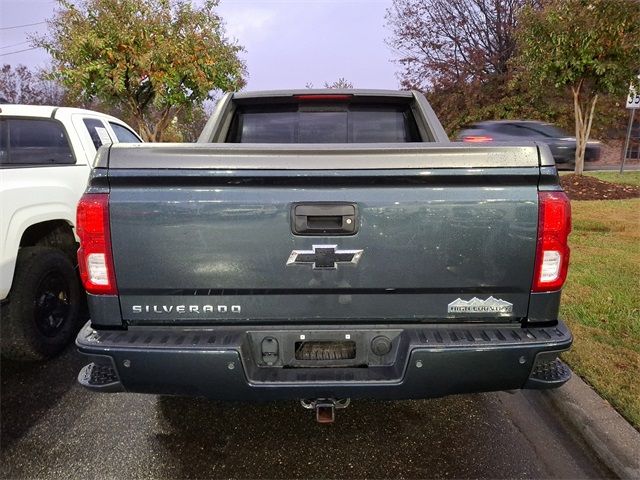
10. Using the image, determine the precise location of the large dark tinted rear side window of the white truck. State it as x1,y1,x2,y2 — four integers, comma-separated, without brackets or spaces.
0,117,76,166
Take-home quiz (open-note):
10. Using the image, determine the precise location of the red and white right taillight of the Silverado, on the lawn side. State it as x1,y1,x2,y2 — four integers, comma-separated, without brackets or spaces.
532,192,571,292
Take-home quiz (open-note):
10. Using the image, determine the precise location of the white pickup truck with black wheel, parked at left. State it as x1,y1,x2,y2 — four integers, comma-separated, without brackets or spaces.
0,104,141,360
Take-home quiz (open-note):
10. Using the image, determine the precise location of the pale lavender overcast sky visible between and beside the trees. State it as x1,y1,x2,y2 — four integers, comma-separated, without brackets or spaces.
0,0,398,90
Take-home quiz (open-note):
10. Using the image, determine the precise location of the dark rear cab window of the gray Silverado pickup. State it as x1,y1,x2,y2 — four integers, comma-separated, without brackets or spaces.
226,100,423,143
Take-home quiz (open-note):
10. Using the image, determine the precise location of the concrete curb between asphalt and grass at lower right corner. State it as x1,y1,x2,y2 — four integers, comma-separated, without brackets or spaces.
544,373,640,480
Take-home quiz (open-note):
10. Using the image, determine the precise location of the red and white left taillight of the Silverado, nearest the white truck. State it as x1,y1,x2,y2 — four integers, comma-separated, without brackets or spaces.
76,193,118,295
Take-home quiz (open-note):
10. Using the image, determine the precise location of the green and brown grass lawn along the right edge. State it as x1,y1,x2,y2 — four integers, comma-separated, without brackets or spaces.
562,198,640,428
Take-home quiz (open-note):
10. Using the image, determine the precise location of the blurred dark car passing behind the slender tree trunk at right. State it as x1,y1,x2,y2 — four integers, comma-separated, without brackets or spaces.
458,120,600,168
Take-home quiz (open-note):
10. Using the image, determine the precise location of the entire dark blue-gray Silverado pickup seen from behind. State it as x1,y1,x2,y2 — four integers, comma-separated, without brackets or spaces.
76,90,572,422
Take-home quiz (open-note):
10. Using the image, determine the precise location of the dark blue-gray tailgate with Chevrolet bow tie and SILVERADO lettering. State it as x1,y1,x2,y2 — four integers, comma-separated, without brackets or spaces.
109,142,539,324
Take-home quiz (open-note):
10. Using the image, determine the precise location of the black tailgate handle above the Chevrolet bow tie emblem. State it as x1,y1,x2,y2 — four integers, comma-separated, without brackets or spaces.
291,203,358,235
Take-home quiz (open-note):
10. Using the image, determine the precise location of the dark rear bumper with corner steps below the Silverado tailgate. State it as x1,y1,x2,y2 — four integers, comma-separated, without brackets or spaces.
76,322,572,401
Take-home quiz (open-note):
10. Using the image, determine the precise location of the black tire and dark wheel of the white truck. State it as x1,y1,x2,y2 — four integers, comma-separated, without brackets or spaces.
0,247,83,361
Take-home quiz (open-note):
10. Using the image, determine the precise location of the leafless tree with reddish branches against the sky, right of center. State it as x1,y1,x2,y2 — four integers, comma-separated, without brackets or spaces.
387,0,537,90
